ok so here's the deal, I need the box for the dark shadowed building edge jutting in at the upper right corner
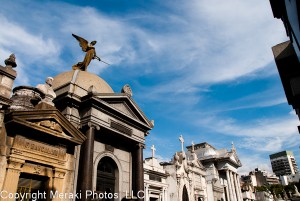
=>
[270,0,300,129]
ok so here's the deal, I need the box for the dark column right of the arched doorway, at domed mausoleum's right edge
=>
[132,143,144,201]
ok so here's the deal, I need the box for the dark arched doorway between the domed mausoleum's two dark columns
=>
[96,156,118,200]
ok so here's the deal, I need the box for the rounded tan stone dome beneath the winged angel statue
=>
[52,70,114,97]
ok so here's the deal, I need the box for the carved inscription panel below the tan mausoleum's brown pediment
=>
[13,135,66,160]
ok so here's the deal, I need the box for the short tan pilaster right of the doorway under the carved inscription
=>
[52,168,68,201]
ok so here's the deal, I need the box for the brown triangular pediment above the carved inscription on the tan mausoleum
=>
[5,109,86,144]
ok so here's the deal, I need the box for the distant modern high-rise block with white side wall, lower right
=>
[270,151,298,177]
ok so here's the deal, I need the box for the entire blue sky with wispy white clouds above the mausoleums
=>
[0,0,300,174]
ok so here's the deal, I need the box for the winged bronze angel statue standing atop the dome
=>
[72,34,108,71]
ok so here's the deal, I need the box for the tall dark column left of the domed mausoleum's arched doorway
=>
[77,123,100,201]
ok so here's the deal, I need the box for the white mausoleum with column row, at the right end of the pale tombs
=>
[187,142,243,201]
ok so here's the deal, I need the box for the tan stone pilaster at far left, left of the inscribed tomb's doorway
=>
[0,158,25,201]
